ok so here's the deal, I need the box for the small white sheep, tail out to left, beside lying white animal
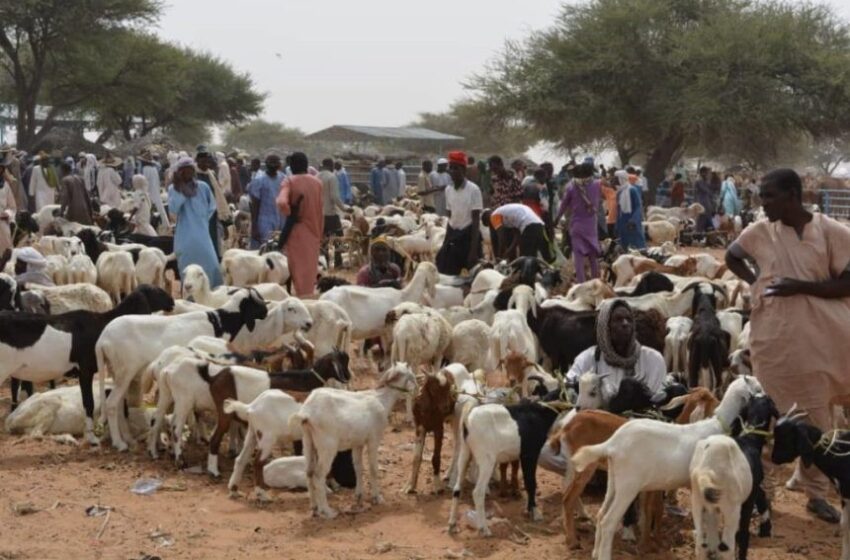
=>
[224,389,306,501]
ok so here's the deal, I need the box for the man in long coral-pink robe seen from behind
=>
[277,152,324,297]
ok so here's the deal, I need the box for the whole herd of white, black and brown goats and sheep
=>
[0,197,850,560]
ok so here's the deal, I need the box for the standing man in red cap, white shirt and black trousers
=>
[437,152,484,275]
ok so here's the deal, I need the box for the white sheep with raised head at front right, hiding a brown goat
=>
[573,377,764,560]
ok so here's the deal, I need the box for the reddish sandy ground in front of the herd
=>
[0,361,840,560]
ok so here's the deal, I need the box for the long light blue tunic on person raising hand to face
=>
[168,181,222,288]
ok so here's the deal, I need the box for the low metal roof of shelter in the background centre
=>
[306,124,464,151]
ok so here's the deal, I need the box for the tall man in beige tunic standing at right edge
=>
[726,169,850,523]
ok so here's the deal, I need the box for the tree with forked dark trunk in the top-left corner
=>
[0,0,160,148]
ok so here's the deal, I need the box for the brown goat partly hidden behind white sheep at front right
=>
[549,410,663,550]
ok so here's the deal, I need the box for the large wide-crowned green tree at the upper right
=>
[470,0,850,195]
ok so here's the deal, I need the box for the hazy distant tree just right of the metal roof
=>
[410,101,535,155]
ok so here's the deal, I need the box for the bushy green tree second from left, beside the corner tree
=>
[84,31,264,142]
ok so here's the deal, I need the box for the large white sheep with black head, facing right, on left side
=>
[95,289,268,451]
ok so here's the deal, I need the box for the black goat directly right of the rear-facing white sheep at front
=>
[735,395,779,560]
